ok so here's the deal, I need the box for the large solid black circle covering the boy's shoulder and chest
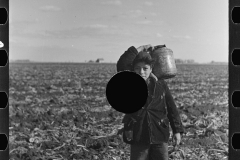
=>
[106,71,148,114]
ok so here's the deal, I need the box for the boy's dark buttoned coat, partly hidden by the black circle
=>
[122,77,184,144]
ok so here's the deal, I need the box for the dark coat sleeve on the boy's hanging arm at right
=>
[163,81,185,134]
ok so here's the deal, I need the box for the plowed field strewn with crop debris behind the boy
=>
[9,63,228,160]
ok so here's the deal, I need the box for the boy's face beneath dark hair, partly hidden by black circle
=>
[134,62,152,81]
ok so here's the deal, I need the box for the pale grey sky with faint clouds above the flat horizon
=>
[9,0,228,63]
